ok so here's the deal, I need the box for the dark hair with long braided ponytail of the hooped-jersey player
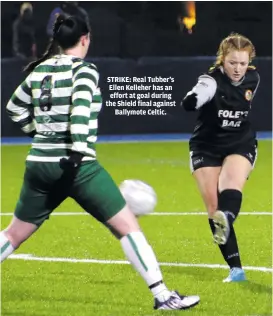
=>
[24,14,90,72]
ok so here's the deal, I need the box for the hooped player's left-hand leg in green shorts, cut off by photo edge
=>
[0,162,69,262]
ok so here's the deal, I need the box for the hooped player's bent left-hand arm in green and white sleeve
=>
[6,76,36,137]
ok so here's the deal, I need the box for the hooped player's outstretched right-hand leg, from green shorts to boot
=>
[71,162,200,310]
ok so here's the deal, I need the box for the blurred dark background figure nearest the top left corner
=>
[12,2,36,58]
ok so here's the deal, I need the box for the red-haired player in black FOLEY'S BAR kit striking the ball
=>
[182,33,260,282]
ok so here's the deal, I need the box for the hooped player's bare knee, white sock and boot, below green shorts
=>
[107,205,200,310]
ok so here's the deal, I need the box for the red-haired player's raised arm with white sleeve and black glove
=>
[182,75,217,111]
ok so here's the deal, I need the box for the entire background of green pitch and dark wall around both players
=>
[1,1,272,316]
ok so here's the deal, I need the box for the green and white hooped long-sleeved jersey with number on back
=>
[7,55,102,162]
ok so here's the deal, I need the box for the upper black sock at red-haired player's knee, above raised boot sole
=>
[218,189,242,225]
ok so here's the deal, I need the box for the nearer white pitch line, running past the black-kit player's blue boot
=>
[8,254,273,273]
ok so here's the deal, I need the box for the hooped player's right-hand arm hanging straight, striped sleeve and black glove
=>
[60,65,99,167]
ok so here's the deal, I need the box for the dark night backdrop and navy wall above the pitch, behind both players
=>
[1,1,272,136]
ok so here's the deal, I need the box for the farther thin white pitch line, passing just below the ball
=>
[0,212,273,216]
